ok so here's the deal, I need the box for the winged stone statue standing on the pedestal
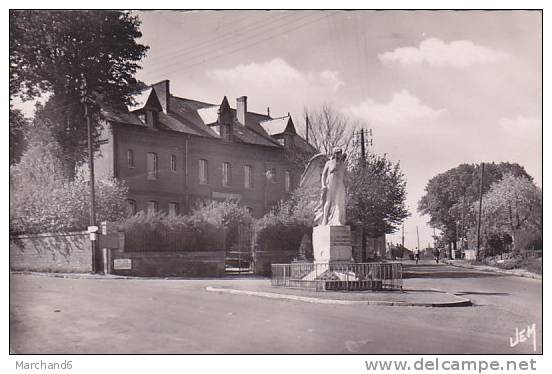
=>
[300,148,347,226]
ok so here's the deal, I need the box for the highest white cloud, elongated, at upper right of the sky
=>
[378,38,507,68]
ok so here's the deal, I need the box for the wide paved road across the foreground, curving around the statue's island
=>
[10,264,542,353]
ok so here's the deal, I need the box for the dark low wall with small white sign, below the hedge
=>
[107,249,226,277]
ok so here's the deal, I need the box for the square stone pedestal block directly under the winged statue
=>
[312,226,353,264]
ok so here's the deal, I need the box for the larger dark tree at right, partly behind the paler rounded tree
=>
[418,162,532,251]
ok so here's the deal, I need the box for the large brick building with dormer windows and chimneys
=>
[96,80,315,217]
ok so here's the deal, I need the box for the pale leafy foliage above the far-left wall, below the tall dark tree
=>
[10,127,128,233]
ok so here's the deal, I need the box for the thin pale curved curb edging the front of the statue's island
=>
[205,286,472,308]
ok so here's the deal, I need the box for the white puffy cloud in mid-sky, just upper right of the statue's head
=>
[346,90,446,125]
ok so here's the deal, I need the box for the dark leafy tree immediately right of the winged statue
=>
[347,154,409,238]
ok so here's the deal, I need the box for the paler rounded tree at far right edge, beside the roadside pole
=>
[482,174,542,250]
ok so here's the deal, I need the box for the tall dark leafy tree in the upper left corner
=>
[9,10,148,172]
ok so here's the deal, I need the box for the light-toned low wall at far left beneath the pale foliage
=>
[10,232,92,273]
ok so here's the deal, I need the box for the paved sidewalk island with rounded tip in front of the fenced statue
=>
[206,281,471,307]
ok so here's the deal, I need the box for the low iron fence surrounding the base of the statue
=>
[272,262,402,291]
